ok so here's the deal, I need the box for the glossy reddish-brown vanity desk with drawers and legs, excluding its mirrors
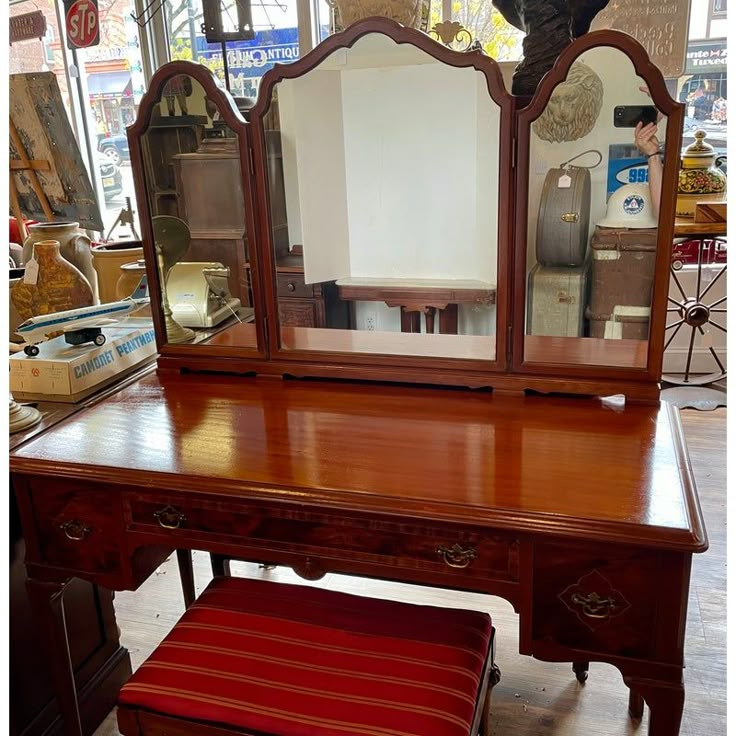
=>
[10,375,707,736]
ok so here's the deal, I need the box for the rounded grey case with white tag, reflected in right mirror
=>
[536,166,590,266]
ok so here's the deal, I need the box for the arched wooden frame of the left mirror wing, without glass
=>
[126,61,267,360]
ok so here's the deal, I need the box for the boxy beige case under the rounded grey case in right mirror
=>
[527,260,590,337]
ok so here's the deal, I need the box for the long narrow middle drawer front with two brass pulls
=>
[126,495,518,582]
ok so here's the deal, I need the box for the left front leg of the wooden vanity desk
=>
[26,578,82,736]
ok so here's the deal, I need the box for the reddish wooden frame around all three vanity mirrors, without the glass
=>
[137,28,684,401]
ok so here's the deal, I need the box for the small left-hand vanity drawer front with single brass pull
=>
[31,481,123,573]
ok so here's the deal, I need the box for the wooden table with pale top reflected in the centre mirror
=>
[337,278,496,335]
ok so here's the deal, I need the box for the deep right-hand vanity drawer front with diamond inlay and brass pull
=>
[532,544,663,657]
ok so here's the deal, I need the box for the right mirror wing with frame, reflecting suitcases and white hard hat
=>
[515,33,681,376]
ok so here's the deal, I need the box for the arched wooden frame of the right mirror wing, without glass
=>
[511,30,685,398]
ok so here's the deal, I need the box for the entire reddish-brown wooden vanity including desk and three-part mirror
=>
[11,18,707,736]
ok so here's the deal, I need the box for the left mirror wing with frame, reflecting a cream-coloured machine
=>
[129,62,259,351]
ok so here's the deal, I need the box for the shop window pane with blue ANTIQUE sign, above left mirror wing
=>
[165,0,299,97]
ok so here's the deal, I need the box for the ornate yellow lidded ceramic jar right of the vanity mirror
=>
[677,130,726,217]
